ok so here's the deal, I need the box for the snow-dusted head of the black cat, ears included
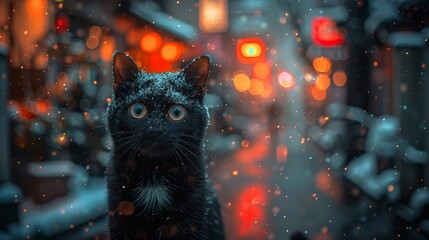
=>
[107,52,210,157]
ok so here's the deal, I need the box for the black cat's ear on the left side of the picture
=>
[113,52,140,91]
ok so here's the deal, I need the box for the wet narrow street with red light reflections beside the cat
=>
[209,20,347,240]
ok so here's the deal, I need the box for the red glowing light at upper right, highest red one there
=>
[311,16,345,47]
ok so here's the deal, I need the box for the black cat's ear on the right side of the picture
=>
[182,56,210,100]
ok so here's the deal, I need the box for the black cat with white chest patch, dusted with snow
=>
[107,52,224,239]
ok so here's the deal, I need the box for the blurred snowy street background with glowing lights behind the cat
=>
[0,0,429,240]
